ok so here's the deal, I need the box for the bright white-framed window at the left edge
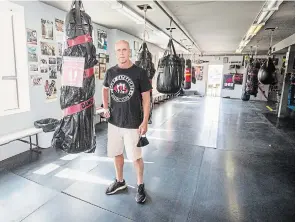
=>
[0,2,30,116]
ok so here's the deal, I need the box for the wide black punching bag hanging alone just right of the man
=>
[156,39,182,94]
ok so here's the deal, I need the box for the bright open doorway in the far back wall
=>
[207,65,223,97]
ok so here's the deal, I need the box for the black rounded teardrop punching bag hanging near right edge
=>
[258,57,275,85]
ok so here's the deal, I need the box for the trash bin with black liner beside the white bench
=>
[34,118,59,149]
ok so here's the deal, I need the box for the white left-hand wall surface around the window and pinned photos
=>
[0,1,163,161]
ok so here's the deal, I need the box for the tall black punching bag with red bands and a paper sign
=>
[52,1,97,153]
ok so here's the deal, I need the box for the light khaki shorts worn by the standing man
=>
[107,123,142,161]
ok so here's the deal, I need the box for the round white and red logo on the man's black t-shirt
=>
[110,75,135,102]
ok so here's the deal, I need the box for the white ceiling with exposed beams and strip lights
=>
[41,0,295,54]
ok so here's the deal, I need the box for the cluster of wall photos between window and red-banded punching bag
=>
[27,18,64,102]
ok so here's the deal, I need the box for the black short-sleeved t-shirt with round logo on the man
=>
[103,65,152,129]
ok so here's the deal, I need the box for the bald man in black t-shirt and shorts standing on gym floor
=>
[102,40,152,203]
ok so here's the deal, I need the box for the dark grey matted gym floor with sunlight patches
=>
[0,97,295,222]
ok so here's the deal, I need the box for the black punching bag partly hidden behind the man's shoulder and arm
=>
[135,42,156,124]
